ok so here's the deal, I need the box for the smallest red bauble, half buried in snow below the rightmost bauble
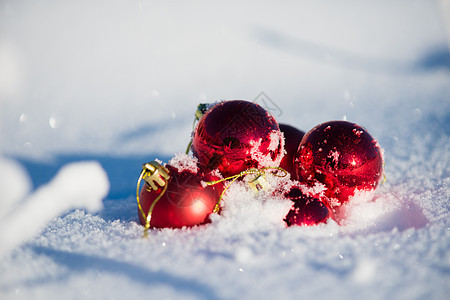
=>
[284,187,334,226]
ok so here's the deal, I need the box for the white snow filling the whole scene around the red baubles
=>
[0,0,450,299]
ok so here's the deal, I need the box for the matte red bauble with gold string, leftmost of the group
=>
[138,166,222,228]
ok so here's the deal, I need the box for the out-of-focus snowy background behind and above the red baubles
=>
[0,0,450,198]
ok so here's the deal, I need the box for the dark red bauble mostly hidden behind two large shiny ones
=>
[279,124,305,178]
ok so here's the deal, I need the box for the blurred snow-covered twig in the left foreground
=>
[0,161,109,257]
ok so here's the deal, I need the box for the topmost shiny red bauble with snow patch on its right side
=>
[192,100,284,177]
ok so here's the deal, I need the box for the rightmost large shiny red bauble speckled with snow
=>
[294,121,383,205]
